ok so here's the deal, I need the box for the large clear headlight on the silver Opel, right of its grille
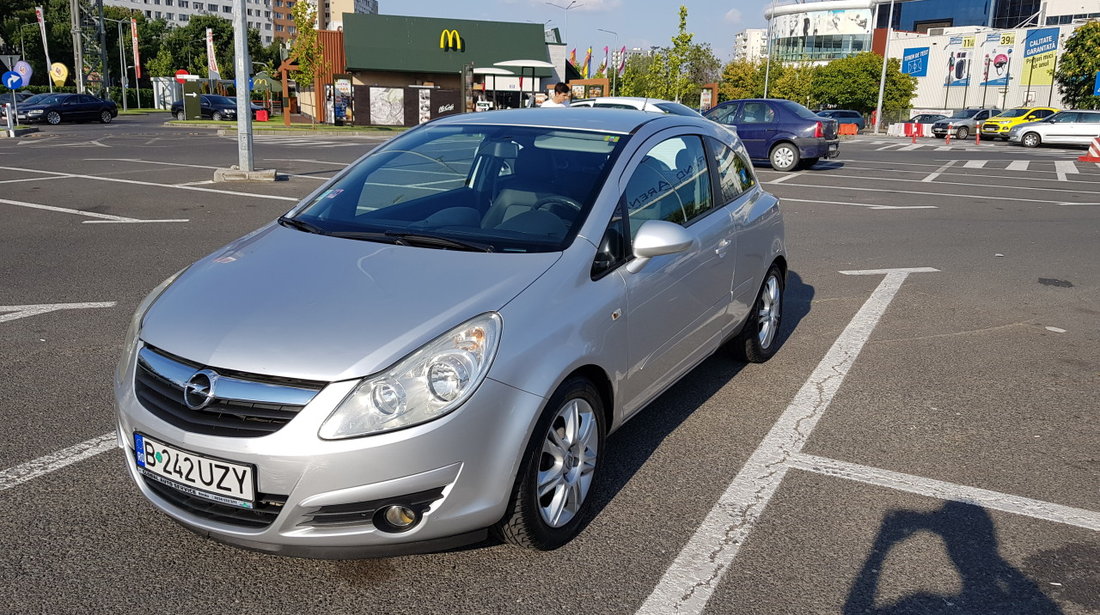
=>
[318,312,502,440]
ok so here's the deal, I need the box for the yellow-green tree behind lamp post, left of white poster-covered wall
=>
[811,52,916,117]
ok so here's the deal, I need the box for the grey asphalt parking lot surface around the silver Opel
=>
[0,116,1100,615]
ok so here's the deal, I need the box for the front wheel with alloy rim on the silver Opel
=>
[493,376,607,551]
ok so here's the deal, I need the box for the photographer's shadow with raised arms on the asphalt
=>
[843,502,1063,615]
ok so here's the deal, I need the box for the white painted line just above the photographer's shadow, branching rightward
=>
[787,453,1100,531]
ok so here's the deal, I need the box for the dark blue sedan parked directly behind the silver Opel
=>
[705,98,840,171]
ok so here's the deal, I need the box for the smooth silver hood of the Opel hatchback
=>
[141,224,561,382]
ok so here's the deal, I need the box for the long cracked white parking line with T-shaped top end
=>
[638,267,937,615]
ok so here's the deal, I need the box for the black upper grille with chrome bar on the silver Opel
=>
[134,347,320,438]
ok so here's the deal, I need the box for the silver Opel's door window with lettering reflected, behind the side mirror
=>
[623,136,713,239]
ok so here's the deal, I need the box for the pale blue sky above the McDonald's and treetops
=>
[378,0,767,64]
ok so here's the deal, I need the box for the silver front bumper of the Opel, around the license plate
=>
[116,341,545,559]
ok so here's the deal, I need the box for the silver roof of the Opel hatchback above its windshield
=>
[431,107,682,134]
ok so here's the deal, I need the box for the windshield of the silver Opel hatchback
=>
[283,125,627,252]
